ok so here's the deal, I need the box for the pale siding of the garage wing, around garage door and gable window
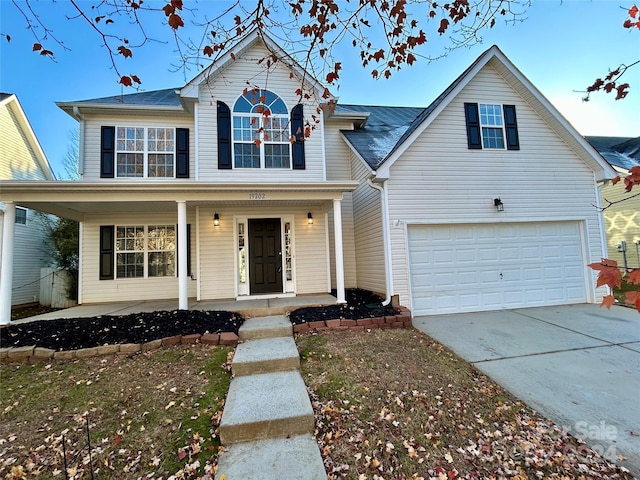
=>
[389,63,602,305]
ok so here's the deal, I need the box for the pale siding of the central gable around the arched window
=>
[198,45,324,182]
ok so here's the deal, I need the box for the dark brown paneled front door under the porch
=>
[248,218,282,295]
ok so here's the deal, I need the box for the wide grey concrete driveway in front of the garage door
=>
[413,304,640,477]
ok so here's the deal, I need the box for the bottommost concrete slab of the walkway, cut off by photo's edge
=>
[215,435,327,480]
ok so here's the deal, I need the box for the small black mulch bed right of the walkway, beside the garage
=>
[289,288,397,325]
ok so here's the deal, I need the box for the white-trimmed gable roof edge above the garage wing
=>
[342,45,615,180]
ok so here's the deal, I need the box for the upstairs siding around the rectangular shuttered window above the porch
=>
[82,115,196,182]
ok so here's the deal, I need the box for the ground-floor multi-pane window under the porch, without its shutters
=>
[115,225,176,278]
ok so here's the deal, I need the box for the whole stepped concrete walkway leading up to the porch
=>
[215,315,327,480]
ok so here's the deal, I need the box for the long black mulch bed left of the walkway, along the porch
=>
[0,310,244,351]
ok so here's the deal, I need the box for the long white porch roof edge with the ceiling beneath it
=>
[0,181,358,221]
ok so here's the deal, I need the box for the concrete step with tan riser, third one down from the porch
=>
[220,371,314,446]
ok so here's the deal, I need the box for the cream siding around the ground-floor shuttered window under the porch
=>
[80,214,196,303]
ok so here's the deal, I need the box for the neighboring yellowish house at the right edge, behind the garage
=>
[587,137,640,268]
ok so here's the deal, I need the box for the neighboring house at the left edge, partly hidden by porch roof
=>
[0,93,54,305]
